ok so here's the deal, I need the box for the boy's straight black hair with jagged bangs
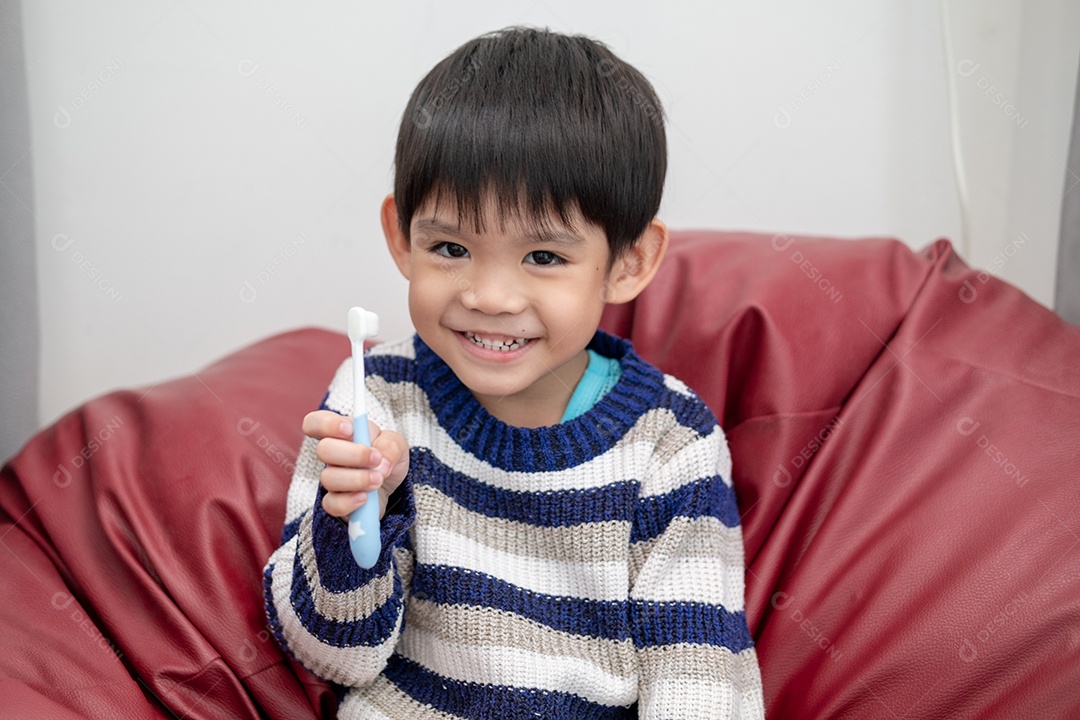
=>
[394,27,667,260]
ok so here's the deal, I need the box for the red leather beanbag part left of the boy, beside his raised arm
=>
[0,330,349,720]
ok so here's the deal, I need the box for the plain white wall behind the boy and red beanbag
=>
[16,0,1080,422]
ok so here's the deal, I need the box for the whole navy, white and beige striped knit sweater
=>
[264,331,764,720]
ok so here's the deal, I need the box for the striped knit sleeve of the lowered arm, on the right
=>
[631,395,765,720]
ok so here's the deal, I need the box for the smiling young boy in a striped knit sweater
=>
[265,28,764,720]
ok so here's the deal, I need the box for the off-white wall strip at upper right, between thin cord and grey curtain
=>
[947,0,1080,305]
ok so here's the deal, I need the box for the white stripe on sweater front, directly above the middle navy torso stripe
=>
[413,525,630,600]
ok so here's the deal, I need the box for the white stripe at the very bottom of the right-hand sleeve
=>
[638,677,765,720]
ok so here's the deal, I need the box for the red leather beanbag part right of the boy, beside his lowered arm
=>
[606,232,1080,719]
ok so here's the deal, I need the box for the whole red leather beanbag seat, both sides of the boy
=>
[0,231,1080,718]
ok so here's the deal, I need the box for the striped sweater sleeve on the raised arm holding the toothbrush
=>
[264,361,415,687]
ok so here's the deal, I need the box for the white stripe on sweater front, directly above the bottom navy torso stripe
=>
[397,628,637,705]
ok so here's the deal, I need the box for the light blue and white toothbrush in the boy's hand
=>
[349,308,382,570]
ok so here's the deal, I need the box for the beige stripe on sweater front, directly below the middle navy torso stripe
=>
[399,598,636,678]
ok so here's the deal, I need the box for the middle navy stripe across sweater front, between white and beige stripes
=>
[413,563,630,640]
